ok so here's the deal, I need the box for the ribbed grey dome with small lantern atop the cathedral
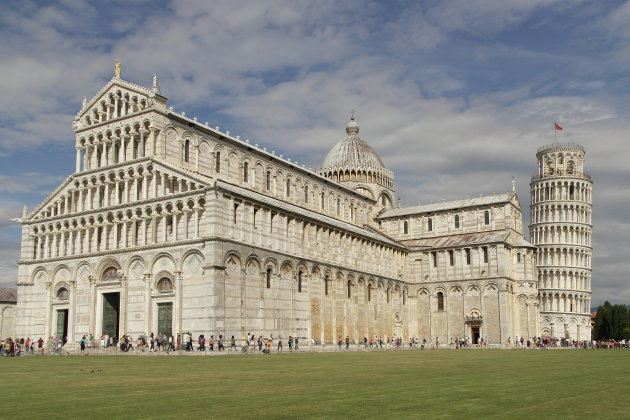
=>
[322,117,385,169]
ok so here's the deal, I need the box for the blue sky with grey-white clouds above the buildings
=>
[0,0,630,306]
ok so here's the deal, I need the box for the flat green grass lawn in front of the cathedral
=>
[0,350,630,419]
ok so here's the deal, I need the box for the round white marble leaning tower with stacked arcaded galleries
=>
[529,143,593,340]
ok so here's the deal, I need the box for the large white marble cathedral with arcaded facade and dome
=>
[16,64,556,345]
